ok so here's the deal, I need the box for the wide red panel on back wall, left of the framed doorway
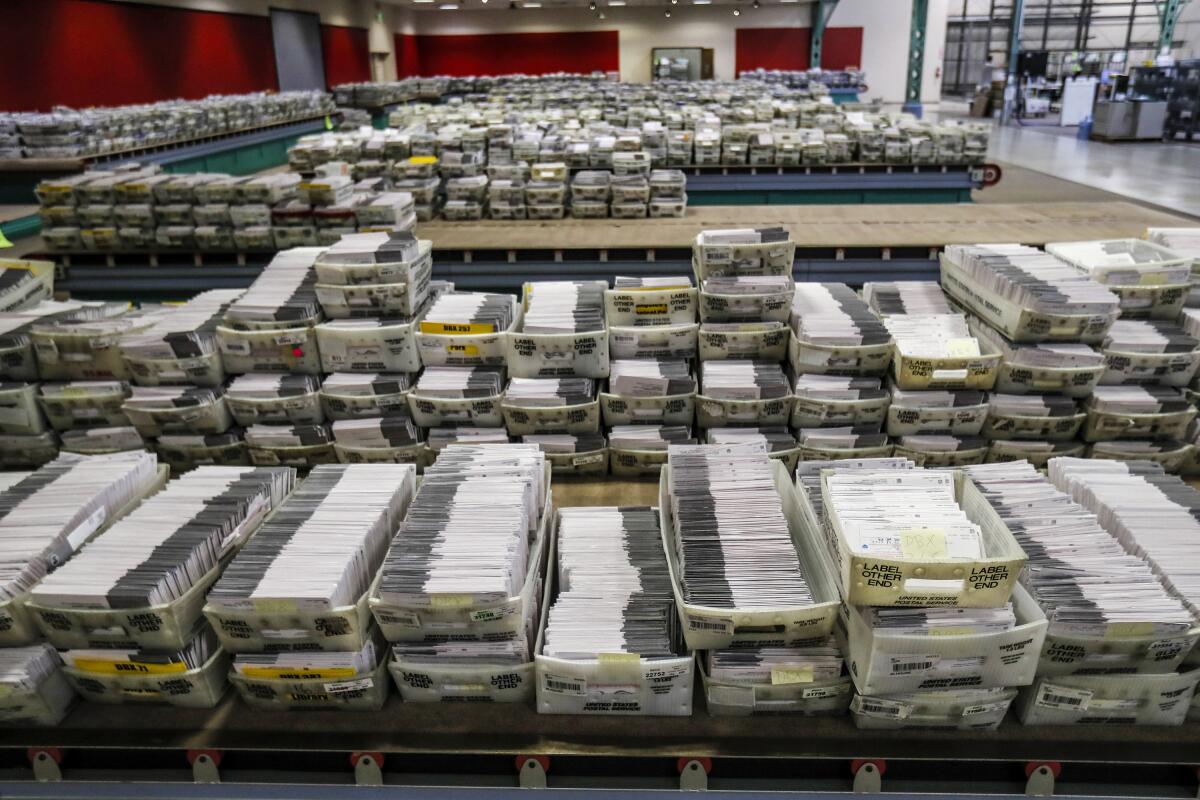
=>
[396,30,620,77]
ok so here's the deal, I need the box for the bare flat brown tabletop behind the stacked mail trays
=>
[418,203,1195,251]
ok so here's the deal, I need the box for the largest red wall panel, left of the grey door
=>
[0,0,278,110]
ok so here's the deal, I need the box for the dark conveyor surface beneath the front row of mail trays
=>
[7,687,1200,764]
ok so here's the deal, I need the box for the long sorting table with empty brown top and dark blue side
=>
[38,203,1192,299]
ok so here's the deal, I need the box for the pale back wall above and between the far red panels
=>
[397,0,926,103]
